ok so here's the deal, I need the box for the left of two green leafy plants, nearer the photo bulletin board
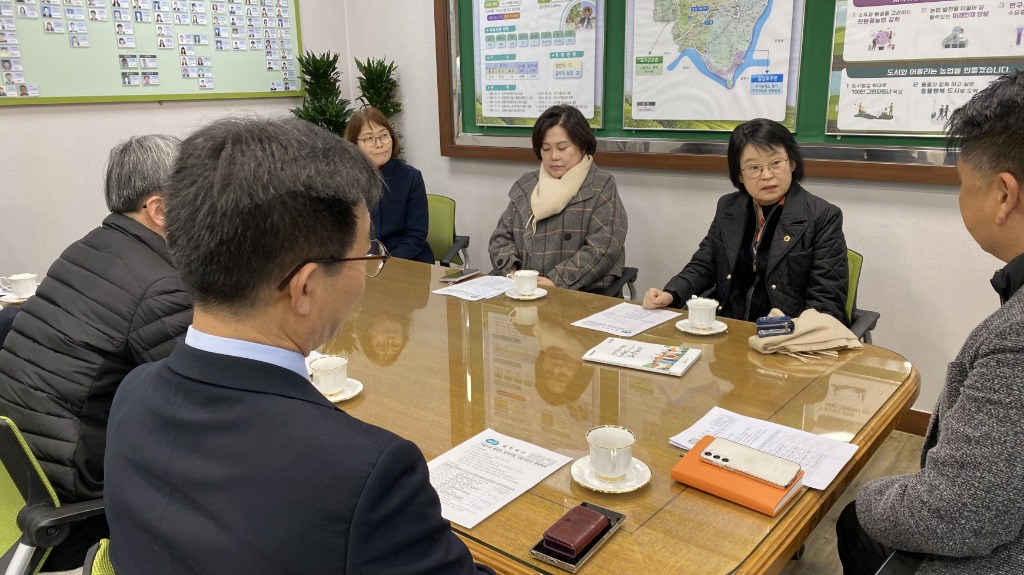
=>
[292,51,353,136]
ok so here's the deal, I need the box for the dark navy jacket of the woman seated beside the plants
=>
[380,159,434,264]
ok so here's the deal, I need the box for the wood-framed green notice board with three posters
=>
[435,0,1024,183]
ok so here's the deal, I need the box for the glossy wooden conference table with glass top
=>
[325,259,919,575]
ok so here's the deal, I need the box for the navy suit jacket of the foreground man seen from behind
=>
[104,344,494,575]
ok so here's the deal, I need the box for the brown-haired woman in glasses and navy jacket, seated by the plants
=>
[345,106,434,264]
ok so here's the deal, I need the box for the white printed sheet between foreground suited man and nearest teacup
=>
[428,429,572,529]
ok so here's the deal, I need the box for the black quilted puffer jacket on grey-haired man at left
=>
[0,214,193,501]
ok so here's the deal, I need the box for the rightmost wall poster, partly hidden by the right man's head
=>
[825,0,1024,136]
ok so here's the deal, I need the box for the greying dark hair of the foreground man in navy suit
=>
[165,118,381,316]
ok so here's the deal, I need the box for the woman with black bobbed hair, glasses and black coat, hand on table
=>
[643,118,848,321]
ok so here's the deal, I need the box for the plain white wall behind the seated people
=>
[0,0,1000,411]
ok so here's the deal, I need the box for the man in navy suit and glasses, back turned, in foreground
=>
[104,119,494,575]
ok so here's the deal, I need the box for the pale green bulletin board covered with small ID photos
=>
[0,0,302,105]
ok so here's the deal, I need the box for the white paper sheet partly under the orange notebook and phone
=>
[669,407,857,489]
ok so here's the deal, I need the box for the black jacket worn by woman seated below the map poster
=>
[665,183,849,322]
